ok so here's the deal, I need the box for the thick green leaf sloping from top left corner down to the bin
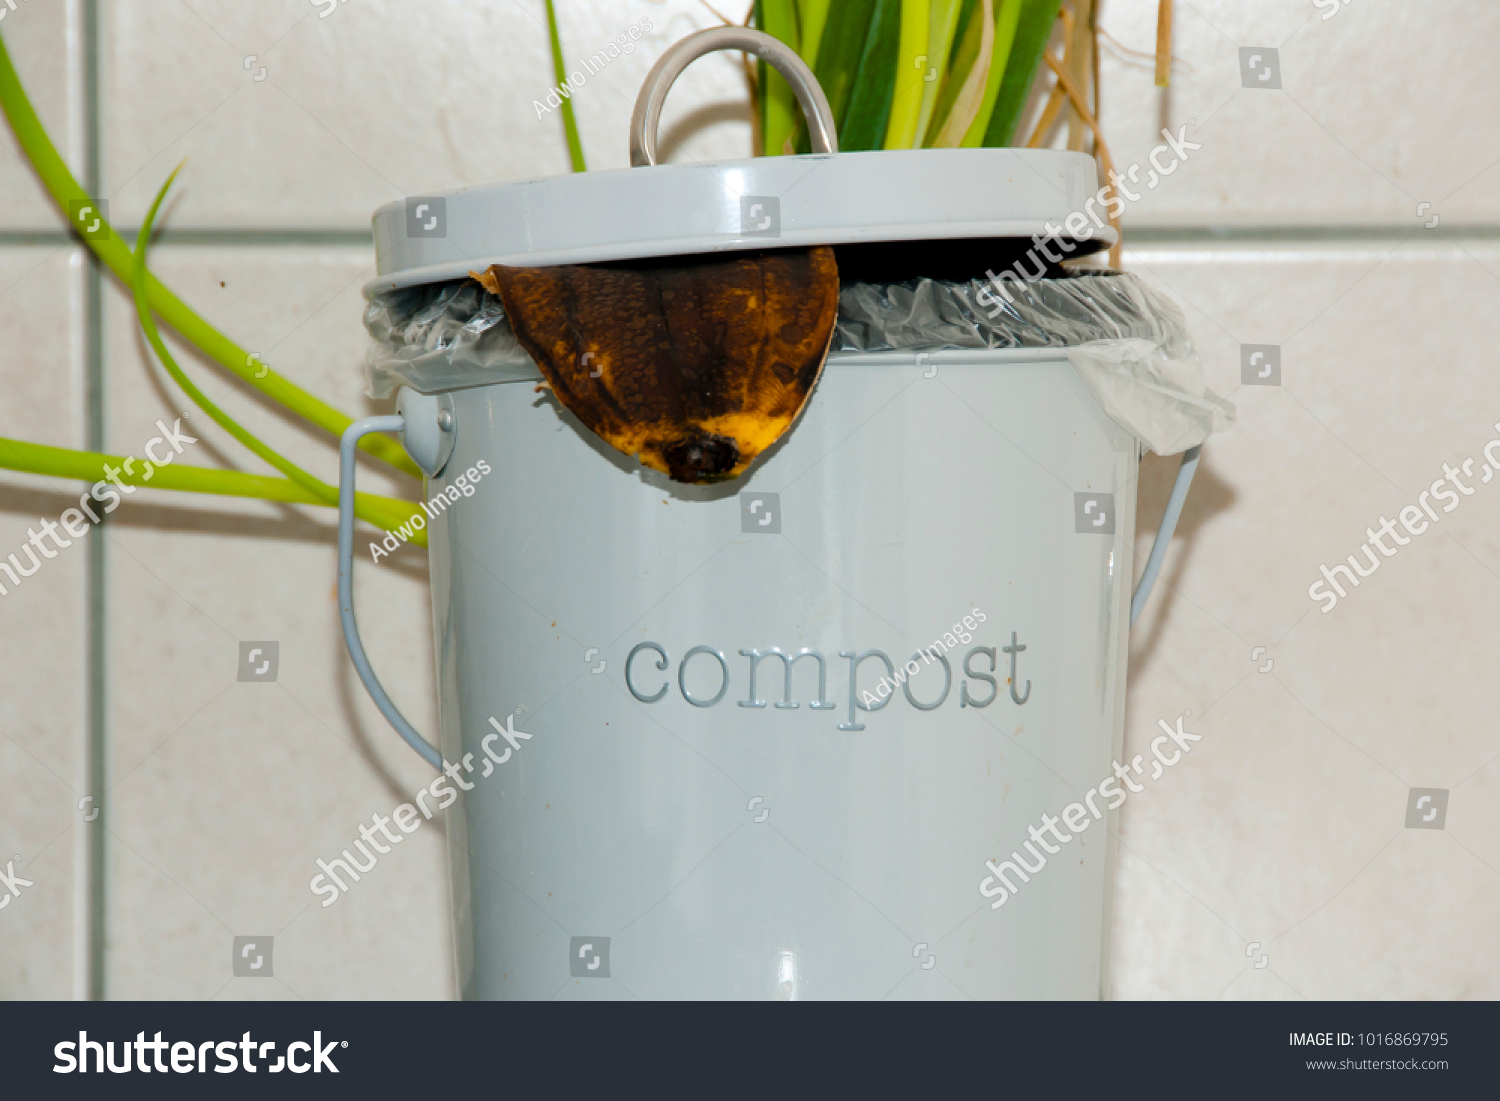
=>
[0,35,422,479]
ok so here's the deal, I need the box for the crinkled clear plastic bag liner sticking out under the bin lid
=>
[365,272,1235,455]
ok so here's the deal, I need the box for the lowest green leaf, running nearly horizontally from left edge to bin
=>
[0,437,428,546]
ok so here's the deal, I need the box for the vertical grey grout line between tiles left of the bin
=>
[84,0,110,1002]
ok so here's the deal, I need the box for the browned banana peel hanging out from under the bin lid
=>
[470,246,839,485]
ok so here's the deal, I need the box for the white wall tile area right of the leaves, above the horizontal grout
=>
[1101,0,1500,228]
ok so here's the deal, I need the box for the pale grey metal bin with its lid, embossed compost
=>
[331,30,1218,999]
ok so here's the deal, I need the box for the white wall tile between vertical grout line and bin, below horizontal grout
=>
[107,248,453,998]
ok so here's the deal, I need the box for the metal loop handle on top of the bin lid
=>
[630,27,839,168]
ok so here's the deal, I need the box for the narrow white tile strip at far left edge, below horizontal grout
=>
[0,246,87,998]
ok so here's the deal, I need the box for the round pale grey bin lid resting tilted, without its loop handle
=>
[365,149,1116,296]
